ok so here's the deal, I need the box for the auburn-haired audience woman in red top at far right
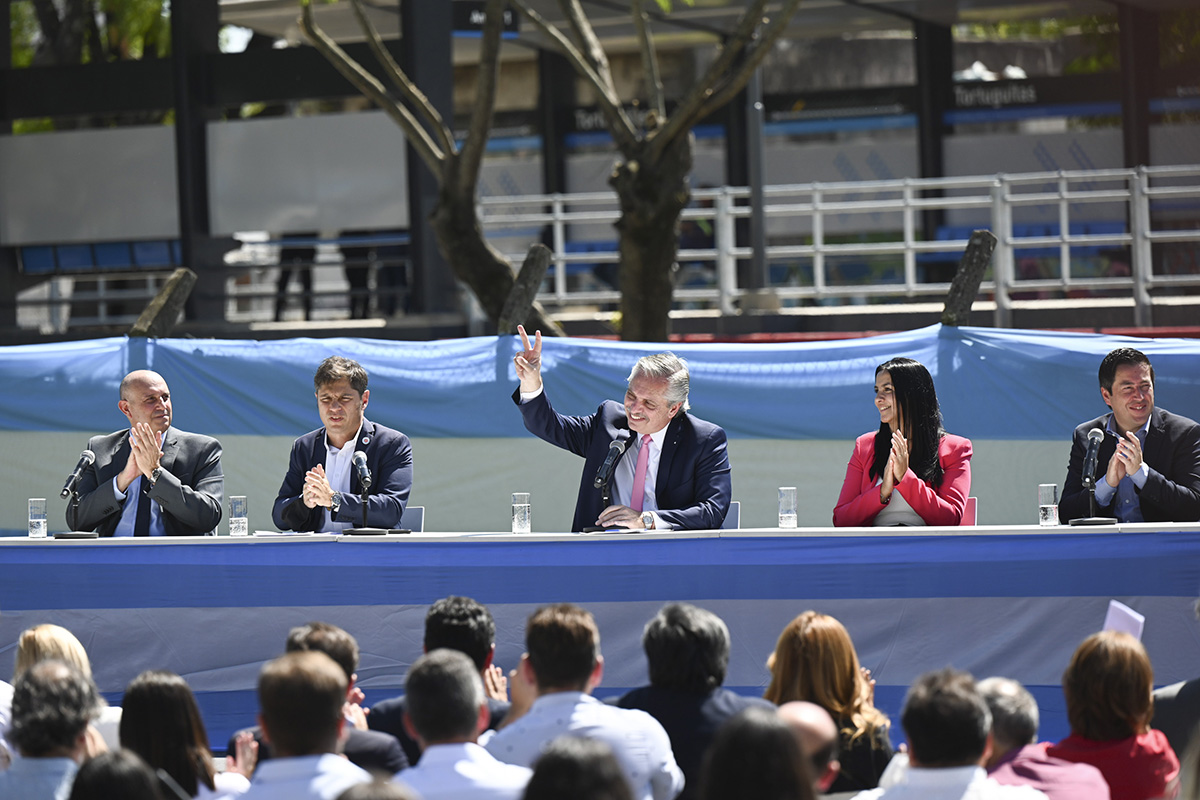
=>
[1046,631,1180,800]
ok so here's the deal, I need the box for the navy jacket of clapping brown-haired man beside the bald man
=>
[271,417,413,530]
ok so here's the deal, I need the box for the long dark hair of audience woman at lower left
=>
[120,669,216,798]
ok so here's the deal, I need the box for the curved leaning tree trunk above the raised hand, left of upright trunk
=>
[430,170,564,336]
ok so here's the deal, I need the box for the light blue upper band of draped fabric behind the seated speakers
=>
[0,325,1200,440]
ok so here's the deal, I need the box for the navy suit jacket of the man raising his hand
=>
[512,387,732,530]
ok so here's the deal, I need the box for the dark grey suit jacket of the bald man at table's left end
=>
[67,427,224,536]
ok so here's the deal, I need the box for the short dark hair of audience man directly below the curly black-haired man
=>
[404,649,485,744]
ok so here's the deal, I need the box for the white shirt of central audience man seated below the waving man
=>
[480,692,683,800]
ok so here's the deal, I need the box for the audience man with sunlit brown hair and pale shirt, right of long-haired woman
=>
[242,652,371,800]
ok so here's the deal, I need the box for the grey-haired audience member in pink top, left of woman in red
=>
[979,678,1109,800]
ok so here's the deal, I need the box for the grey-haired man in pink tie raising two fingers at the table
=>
[512,326,732,531]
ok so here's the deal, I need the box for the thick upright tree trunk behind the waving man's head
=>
[608,134,692,342]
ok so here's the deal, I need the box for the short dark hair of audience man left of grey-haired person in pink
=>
[900,667,991,768]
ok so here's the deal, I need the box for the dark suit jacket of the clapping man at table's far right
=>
[1058,408,1200,523]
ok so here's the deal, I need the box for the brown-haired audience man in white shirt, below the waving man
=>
[486,603,683,800]
